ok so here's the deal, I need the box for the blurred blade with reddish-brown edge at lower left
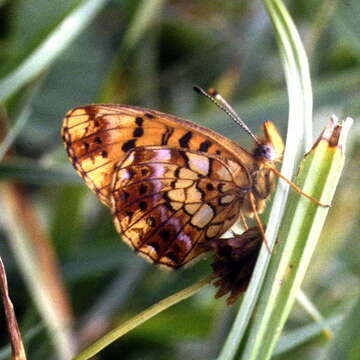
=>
[0,183,74,360]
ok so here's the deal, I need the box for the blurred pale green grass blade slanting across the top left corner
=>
[0,0,108,101]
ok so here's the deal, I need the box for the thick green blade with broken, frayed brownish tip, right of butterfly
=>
[241,119,352,360]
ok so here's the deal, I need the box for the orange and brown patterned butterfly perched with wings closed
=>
[62,90,326,268]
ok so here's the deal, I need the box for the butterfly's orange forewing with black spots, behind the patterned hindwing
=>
[62,105,253,206]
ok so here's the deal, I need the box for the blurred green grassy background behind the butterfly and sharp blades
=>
[0,0,360,360]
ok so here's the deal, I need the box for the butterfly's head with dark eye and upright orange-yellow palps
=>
[253,121,284,162]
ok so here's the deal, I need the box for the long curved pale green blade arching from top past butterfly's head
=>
[218,0,312,360]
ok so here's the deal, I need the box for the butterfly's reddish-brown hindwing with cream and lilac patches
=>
[110,146,250,268]
